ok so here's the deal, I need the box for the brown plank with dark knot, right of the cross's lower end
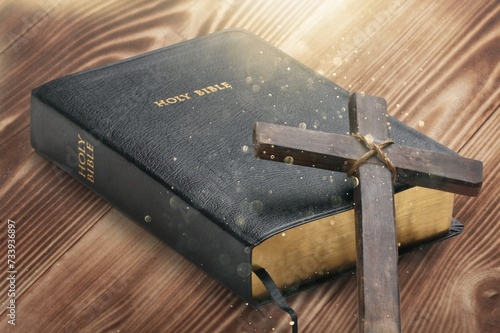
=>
[399,102,500,332]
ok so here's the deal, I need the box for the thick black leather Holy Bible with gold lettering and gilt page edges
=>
[31,30,463,305]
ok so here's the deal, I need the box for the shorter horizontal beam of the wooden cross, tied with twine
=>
[254,123,483,196]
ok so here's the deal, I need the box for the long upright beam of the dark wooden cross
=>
[349,93,401,332]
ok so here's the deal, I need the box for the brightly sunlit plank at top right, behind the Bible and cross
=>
[279,0,500,150]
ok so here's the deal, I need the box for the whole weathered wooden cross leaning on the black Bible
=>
[254,93,482,332]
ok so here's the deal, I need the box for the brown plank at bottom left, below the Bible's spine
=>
[0,209,239,332]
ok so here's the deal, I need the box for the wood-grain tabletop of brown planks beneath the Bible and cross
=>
[0,0,500,332]
